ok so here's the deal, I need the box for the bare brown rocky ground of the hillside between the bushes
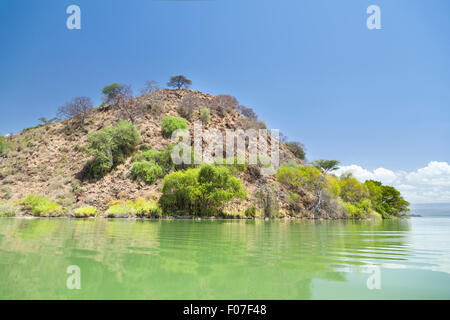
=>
[0,90,311,216]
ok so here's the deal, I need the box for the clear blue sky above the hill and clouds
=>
[0,0,450,178]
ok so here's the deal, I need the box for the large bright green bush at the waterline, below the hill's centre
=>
[160,164,245,215]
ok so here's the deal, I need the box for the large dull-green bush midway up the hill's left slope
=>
[85,121,140,179]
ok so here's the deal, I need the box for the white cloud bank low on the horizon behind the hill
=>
[335,161,450,203]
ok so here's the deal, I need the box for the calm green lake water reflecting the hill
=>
[0,218,450,299]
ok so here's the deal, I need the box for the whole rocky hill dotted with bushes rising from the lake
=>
[0,76,409,219]
